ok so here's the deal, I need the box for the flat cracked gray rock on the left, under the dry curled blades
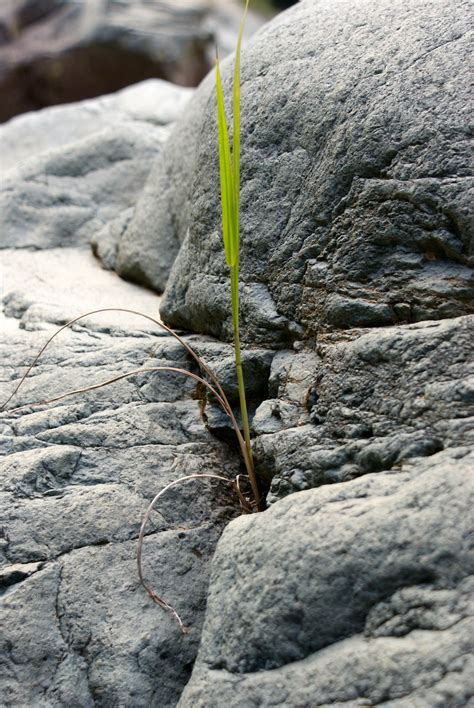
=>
[0,248,244,708]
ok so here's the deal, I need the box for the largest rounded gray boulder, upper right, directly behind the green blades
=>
[113,0,474,342]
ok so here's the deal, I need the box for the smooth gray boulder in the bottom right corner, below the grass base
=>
[179,448,474,708]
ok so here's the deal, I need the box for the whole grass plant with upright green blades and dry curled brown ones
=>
[0,0,262,632]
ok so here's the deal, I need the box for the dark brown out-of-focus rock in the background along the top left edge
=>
[0,0,294,122]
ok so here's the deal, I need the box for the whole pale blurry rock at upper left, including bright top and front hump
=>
[0,81,190,252]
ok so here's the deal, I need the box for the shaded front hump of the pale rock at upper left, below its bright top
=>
[0,128,160,248]
